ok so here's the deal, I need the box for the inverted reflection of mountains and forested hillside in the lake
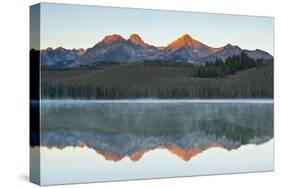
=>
[36,101,273,161]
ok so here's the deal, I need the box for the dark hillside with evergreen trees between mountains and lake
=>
[41,52,273,99]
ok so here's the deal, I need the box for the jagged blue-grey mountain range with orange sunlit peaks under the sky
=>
[41,34,273,67]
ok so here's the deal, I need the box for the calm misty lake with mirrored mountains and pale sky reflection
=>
[34,99,274,185]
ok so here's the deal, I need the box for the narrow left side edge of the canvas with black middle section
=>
[29,3,41,185]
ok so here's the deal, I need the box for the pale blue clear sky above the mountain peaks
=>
[38,3,274,54]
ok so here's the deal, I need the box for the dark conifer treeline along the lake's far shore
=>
[41,82,272,99]
